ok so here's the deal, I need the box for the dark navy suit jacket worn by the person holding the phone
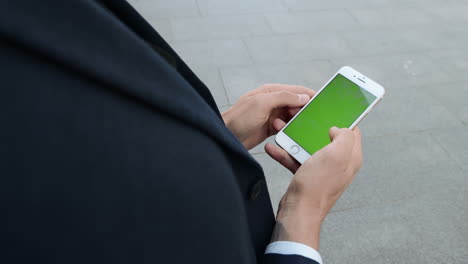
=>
[0,0,315,264]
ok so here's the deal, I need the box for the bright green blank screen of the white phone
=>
[284,74,376,154]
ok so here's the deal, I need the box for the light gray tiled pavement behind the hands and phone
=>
[131,0,468,264]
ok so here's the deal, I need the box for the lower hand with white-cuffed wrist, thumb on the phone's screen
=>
[265,127,362,249]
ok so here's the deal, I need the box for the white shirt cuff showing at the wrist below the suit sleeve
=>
[265,241,322,264]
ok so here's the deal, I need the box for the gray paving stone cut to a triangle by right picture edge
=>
[431,126,468,171]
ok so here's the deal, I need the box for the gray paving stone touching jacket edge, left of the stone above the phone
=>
[172,40,252,67]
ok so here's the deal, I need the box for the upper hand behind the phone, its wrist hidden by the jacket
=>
[222,84,315,149]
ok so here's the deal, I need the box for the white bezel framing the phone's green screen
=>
[275,66,385,164]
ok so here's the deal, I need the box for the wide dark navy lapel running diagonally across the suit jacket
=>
[0,0,259,167]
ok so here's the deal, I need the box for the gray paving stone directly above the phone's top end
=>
[245,33,354,63]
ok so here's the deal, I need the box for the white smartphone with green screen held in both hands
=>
[275,66,385,164]
